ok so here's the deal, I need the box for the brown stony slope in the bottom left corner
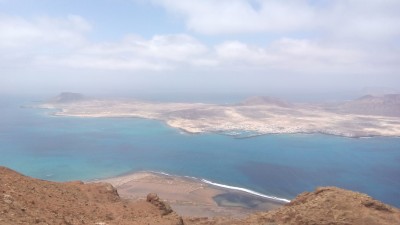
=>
[0,167,182,225]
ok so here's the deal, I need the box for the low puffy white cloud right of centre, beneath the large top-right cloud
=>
[216,38,365,73]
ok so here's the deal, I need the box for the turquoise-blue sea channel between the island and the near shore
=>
[0,100,400,207]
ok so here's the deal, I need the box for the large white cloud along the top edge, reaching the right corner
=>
[151,0,400,41]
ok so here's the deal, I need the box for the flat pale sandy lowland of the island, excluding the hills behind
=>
[37,100,400,139]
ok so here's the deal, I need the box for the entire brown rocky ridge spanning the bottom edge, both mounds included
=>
[0,167,400,225]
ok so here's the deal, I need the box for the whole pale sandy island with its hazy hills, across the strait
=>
[39,93,400,138]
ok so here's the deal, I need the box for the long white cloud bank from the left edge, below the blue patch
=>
[0,15,215,70]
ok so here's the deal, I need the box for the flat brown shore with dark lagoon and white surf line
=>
[88,171,289,217]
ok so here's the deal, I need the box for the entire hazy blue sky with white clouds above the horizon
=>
[0,0,400,100]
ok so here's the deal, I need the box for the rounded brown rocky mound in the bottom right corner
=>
[246,187,400,225]
